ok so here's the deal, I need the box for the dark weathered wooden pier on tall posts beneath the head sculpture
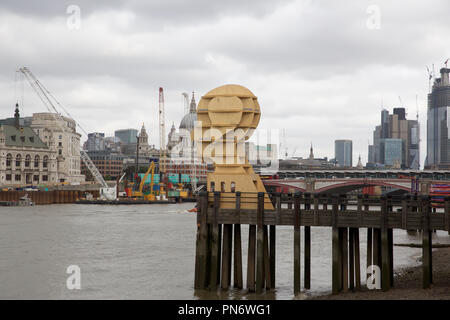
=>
[195,192,450,294]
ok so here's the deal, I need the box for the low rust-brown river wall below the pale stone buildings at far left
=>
[0,190,99,205]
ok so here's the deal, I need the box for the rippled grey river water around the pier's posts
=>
[0,203,449,299]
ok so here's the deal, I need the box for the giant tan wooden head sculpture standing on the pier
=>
[194,84,273,209]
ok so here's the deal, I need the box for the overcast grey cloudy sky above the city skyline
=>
[0,0,450,166]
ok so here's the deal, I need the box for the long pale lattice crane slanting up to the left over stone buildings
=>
[18,67,116,200]
